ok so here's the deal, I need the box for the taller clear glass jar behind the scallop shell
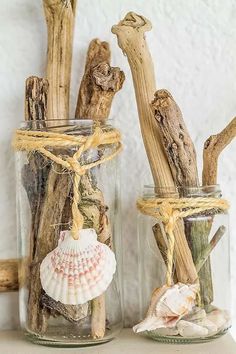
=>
[16,120,122,347]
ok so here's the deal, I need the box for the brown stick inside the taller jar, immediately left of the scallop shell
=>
[28,166,71,333]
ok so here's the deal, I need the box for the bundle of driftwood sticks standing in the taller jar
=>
[0,0,124,338]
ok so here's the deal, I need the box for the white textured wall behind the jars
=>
[0,0,236,328]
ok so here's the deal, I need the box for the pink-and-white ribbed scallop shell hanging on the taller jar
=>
[40,229,116,305]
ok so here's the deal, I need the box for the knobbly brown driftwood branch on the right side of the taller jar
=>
[75,39,124,338]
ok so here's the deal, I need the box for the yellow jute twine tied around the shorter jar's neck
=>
[137,197,229,286]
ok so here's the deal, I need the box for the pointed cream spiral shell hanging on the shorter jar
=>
[133,283,199,333]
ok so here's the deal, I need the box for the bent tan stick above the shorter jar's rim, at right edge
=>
[202,117,236,186]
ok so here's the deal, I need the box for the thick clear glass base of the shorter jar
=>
[145,328,228,344]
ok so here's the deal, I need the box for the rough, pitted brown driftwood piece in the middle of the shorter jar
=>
[151,90,213,306]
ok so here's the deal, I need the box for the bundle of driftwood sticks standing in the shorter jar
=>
[112,12,236,308]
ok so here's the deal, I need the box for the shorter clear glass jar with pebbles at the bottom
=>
[134,185,231,343]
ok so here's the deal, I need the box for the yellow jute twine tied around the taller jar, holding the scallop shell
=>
[13,127,122,239]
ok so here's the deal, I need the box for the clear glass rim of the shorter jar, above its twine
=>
[143,184,222,198]
